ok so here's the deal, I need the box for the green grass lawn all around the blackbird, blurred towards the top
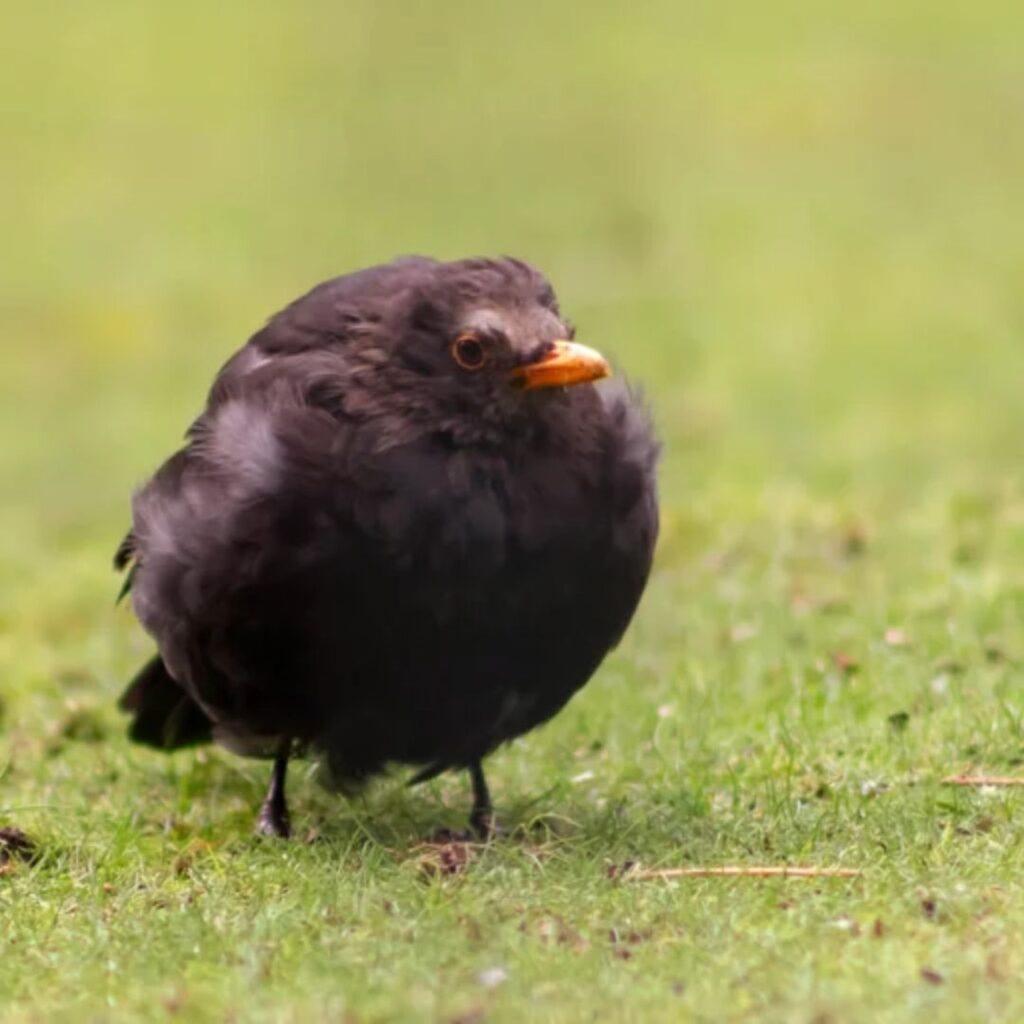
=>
[0,0,1024,1024]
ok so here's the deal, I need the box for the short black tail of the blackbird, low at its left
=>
[118,654,213,751]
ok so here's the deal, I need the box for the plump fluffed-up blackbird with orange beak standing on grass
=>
[115,251,657,837]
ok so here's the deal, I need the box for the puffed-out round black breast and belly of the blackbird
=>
[140,387,656,777]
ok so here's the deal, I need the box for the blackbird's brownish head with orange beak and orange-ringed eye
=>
[254,257,610,434]
